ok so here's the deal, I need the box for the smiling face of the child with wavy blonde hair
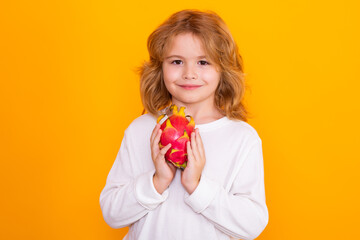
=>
[162,33,220,109]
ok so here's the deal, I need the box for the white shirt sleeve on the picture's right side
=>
[185,139,269,240]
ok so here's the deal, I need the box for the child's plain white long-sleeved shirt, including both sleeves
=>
[100,114,268,240]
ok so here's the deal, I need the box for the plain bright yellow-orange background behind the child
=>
[0,0,360,240]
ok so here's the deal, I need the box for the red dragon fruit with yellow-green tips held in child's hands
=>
[157,105,195,170]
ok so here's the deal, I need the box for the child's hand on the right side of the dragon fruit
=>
[181,128,206,194]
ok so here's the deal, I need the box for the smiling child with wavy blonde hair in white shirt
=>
[100,10,268,240]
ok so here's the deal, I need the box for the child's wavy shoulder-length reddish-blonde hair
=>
[139,10,248,121]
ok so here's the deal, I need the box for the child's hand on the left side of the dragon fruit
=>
[150,124,176,194]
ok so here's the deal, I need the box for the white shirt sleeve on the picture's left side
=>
[100,131,169,228]
